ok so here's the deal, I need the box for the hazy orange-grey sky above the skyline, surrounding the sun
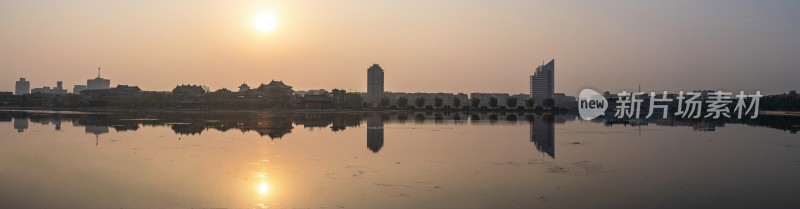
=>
[0,0,800,95]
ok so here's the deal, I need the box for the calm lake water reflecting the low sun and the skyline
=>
[0,111,800,209]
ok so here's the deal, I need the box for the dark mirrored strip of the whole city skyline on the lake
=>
[0,111,800,155]
